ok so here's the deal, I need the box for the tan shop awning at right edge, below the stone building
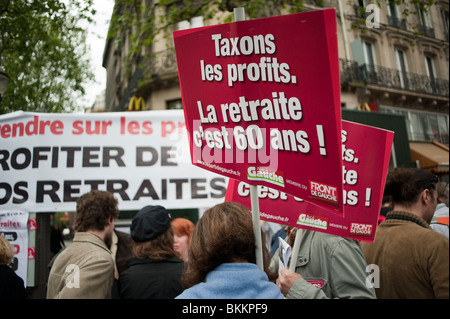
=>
[409,141,449,174]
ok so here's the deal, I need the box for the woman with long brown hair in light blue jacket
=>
[177,202,283,299]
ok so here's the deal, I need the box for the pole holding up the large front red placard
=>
[233,8,264,270]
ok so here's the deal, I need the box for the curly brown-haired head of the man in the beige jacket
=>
[75,190,119,232]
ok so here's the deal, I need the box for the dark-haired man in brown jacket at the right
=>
[361,168,449,299]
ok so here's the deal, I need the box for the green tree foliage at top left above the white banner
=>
[0,0,95,114]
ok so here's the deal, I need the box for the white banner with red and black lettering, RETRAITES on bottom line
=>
[0,110,227,212]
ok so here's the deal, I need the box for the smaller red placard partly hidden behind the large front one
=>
[225,121,394,242]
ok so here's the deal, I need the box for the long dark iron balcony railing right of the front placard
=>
[340,59,449,97]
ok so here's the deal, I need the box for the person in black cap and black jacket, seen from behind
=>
[119,205,184,299]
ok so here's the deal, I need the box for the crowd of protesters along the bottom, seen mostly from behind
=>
[0,168,449,299]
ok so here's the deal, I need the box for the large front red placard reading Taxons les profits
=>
[174,9,343,216]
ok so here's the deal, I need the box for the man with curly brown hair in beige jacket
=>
[47,190,119,299]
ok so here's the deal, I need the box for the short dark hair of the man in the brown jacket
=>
[384,167,438,206]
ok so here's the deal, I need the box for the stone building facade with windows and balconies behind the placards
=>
[103,0,449,145]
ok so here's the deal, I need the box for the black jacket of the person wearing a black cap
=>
[119,257,184,299]
